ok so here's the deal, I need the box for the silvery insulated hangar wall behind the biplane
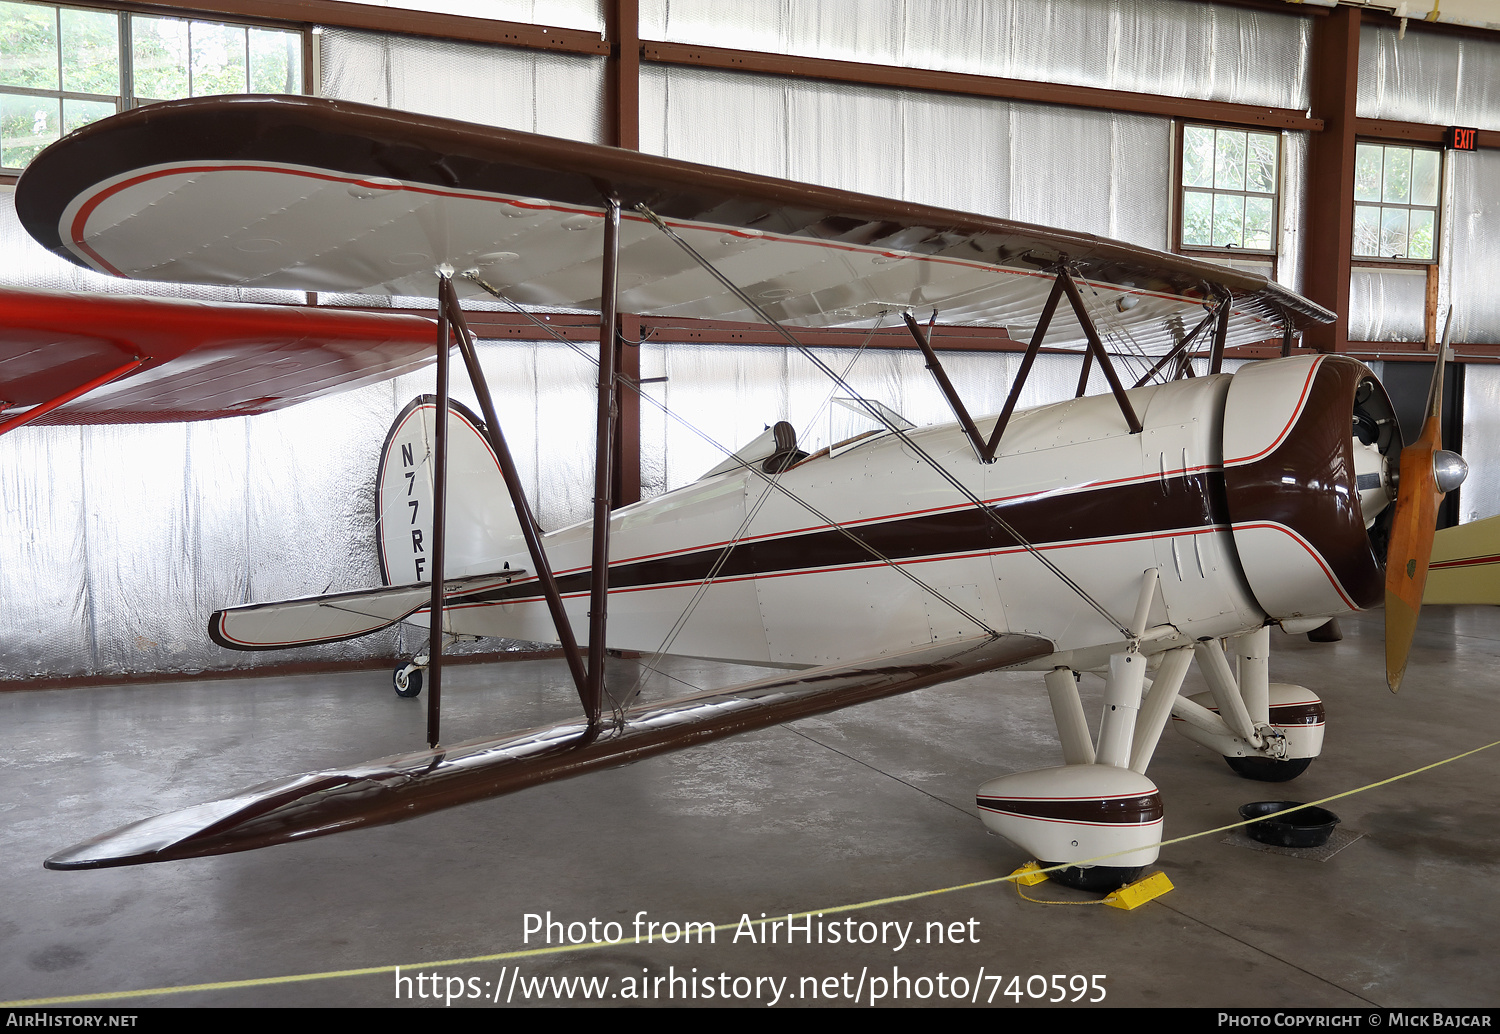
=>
[0,0,1500,678]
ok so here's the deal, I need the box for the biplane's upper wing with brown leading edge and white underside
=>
[17,98,1334,351]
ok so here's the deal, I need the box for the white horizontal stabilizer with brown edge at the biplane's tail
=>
[209,567,527,650]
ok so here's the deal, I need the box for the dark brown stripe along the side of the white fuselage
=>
[464,471,1229,606]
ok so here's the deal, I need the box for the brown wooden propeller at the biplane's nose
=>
[1386,309,1467,693]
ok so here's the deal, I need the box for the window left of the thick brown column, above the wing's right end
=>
[1179,126,1281,255]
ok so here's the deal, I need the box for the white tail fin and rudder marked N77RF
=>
[375,395,527,585]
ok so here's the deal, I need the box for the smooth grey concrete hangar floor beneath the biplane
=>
[0,608,1500,1007]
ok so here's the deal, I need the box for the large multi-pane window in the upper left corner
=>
[0,0,302,171]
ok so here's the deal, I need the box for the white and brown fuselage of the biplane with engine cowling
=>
[426,359,1383,668]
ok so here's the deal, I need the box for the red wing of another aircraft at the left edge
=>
[0,283,437,425]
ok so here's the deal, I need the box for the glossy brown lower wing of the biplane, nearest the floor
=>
[47,635,1053,869]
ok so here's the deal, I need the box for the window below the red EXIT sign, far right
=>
[1355,144,1443,263]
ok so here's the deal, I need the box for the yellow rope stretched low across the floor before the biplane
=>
[0,740,1500,1008]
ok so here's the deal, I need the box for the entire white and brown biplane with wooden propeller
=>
[8,98,1466,887]
